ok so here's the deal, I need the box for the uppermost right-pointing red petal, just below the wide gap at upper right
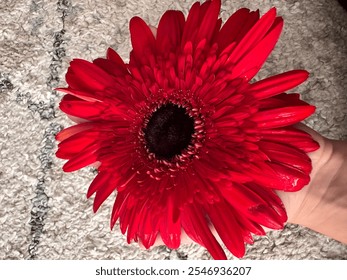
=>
[249,70,309,99]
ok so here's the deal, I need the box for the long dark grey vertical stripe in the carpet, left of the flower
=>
[28,0,71,259]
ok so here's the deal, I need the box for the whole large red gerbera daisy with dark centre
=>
[57,0,318,259]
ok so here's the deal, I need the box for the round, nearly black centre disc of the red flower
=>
[144,103,194,159]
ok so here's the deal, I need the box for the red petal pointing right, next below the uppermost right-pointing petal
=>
[252,105,315,129]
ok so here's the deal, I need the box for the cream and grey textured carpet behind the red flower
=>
[0,0,347,259]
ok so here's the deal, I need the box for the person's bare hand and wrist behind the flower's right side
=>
[278,125,347,244]
